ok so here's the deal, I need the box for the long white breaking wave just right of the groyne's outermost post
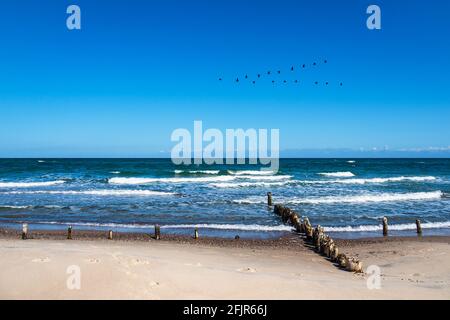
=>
[286,191,443,204]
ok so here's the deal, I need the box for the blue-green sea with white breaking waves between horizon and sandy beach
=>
[0,159,450,238]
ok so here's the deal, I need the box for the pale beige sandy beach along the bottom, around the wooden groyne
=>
[0,230,450,299]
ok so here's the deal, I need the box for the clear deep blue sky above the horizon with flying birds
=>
[0,0,450,157]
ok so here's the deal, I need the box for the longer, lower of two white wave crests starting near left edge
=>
[4,189,175,196]
